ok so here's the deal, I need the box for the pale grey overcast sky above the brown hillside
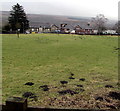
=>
[0,0,120,19]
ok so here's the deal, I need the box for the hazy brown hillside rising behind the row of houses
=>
[0,11,116,28]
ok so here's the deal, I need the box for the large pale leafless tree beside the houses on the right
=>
[92,14,108,34]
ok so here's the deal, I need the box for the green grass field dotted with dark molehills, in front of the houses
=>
[2,34,118,107]
